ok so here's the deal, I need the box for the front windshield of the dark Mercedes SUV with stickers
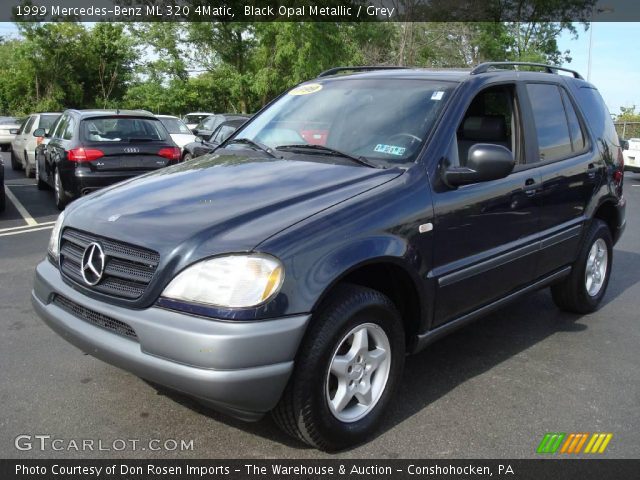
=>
[235,78,455,166]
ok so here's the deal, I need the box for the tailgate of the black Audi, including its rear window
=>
[79,117,179,172]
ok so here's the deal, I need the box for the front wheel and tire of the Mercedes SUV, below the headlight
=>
[272,285,405,451]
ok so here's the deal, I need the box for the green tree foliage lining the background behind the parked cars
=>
[0,19,592,114]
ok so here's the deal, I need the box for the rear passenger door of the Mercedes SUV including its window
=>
[526,83,605,276]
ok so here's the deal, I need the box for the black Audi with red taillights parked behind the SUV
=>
[33,110,181,210]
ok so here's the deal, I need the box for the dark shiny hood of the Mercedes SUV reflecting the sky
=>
[65,154,403,263]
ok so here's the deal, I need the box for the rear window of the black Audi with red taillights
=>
[80,117,167,142]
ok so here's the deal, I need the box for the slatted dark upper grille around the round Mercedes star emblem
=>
[60,228,160,300]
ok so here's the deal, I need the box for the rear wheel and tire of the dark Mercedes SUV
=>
[551,218,613,314]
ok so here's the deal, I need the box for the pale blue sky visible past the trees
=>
[0,20,640,114]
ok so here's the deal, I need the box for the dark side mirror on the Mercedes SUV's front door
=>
[442,143,516,187]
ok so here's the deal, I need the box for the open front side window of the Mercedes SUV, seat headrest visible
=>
[454,85,522,166]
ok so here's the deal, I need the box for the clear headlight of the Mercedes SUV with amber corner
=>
[162,254,284,307]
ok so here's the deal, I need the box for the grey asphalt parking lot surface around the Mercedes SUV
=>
[0,153,640,458]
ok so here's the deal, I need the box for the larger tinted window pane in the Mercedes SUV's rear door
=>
[527,83,572,162]
